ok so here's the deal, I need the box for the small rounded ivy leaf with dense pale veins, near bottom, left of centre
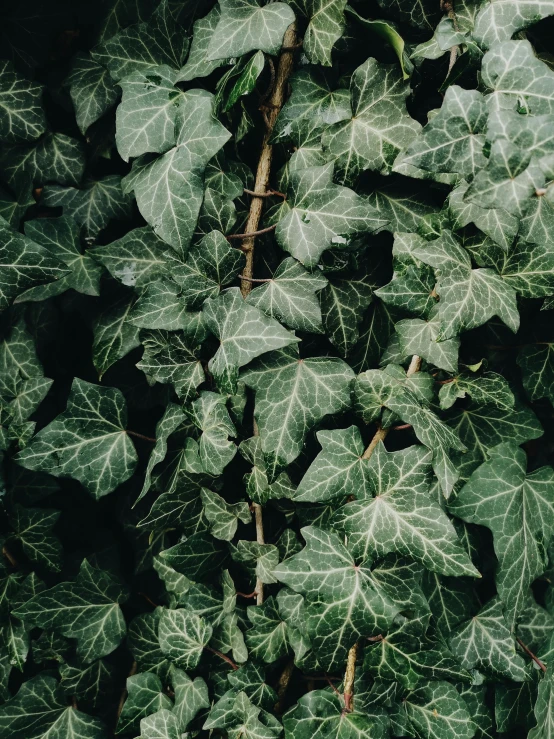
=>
[159,609,212,670]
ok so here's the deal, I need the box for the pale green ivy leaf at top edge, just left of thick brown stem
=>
[208,0,294,60]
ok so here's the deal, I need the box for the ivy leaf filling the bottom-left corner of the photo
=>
[0,675,105,739]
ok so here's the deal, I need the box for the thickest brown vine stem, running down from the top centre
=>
[241,23,296,297]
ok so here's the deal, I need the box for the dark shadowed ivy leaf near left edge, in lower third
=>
[10,505,63,572]
